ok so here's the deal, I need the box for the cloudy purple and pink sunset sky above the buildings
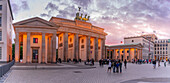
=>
[11,0,170,45]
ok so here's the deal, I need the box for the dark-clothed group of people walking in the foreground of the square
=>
[107,59,127,73]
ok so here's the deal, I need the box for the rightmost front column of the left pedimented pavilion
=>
[52,33,56,63]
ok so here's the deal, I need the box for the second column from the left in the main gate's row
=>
[74,33,79,60]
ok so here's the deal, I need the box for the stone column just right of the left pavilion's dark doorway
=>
[41,33,45,63]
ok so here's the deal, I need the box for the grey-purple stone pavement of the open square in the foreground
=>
[5,63,170,83]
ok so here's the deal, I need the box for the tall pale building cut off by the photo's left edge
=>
[0,0,13,62]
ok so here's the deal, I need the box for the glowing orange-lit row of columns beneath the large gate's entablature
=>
[58,32,105,61]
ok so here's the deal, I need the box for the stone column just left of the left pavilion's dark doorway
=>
[26,32,31,63]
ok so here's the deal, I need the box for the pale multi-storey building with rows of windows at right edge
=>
[154,39,170,60]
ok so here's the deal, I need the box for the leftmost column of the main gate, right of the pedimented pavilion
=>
[63,33,68,61]
